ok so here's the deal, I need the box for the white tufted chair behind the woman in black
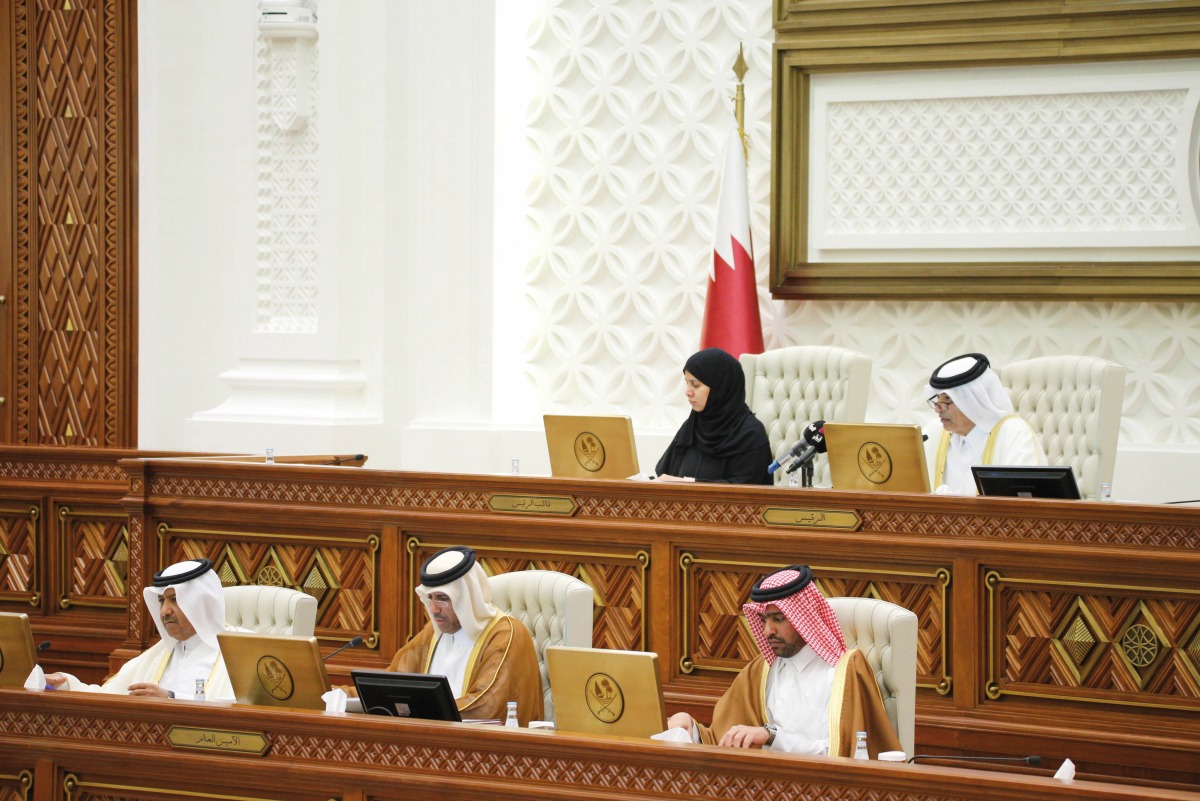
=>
[742,345,871,486]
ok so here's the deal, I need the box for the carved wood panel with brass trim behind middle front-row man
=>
[402,536,650,651]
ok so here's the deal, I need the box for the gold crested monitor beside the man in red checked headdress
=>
[546,645,667,737]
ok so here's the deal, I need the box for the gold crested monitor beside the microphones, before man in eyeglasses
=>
[824,422,929,493]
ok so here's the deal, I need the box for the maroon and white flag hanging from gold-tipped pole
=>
[700,130,762,356]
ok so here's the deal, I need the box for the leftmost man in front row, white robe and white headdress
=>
[46,559,234,701]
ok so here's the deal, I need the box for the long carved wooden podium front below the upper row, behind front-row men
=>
[0,448,1200,787]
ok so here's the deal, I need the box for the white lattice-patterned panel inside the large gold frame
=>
[814,88,1198,244]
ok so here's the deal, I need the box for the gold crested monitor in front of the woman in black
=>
[542,415,638,478]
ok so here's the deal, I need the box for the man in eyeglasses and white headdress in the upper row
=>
[925,354,1045,495]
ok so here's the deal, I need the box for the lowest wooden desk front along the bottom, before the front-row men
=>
[0,689,1200,801]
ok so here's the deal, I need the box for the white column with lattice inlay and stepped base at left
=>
[186,0,384,453]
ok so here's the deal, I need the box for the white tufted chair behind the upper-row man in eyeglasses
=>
[997,356,1128,499]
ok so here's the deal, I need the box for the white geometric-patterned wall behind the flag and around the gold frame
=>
[512,0,1200,450]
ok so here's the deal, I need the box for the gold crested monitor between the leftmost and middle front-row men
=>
[217,632,329,710]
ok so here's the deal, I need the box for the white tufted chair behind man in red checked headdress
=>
[829,598,917,757]
